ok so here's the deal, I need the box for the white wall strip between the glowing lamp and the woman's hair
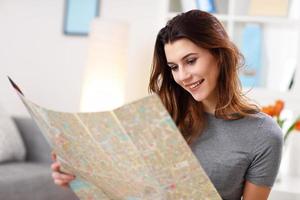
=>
[101,0,169,102]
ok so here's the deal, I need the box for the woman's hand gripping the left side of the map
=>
[51,153,75,187]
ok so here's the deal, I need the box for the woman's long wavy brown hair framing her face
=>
[149,10,259,144]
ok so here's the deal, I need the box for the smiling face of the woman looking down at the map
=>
[164,39,219,104]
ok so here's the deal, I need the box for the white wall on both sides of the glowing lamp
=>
[0,0,168,115]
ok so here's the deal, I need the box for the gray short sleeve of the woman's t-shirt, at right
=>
[245,116,283,187]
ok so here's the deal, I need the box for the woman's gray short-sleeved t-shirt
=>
[192,113,283,200]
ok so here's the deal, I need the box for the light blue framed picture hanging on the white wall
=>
[63,0,100,36]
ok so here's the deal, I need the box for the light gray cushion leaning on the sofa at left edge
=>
[0,108,26,163]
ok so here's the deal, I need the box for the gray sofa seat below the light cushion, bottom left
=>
[0,162,78,200]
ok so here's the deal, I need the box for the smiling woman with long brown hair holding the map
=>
[52,10,282,200]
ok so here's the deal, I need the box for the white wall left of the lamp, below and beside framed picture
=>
[0,0,88,115]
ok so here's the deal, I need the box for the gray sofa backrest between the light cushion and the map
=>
[13,117,51,163]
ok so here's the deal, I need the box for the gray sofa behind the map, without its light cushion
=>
[0,118,78,200]
